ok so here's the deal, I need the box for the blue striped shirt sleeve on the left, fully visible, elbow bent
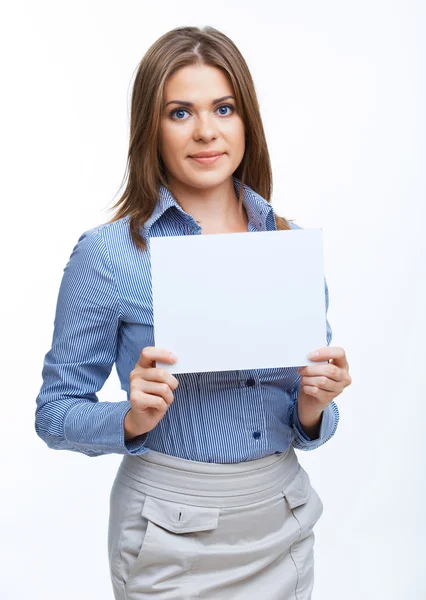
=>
[35,229,148,456]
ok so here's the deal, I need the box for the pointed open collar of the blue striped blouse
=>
[144,176,272,232]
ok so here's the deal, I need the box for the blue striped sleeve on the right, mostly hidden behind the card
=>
[289,278,339,450]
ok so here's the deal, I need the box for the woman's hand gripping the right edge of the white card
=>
[297,346,352,417]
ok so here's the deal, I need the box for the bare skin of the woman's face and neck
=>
[159,65,248,233]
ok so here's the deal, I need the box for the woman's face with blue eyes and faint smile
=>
[160,65,245,188]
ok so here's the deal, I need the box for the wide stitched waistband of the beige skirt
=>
[117,445,300,507]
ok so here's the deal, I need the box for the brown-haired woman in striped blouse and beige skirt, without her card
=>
[35,27,351,600]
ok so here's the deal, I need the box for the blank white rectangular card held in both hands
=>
[150,229,327,373]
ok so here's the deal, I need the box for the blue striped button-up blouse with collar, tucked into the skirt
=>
[35,177,339,463]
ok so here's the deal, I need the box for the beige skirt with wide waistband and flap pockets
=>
[108,446,323,600]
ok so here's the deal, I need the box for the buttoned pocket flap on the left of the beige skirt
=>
[142,496,219,533]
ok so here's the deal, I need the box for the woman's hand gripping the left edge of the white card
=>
[124,346,179,440]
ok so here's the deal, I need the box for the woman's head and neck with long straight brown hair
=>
[104,27,291,249]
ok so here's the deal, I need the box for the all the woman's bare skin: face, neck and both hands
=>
[124,66,352,440]
